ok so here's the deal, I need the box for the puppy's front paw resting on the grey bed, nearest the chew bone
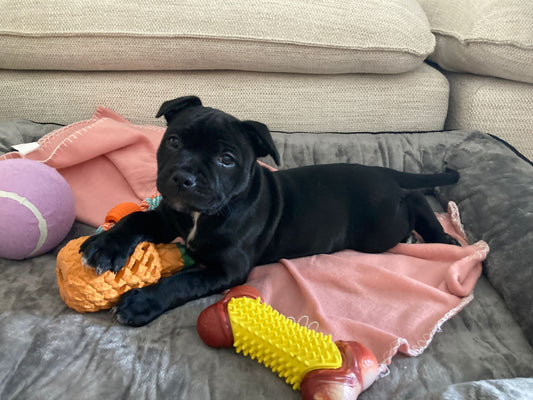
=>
[114,289,165,326]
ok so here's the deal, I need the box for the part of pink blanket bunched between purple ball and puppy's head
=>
[0,107,165,226]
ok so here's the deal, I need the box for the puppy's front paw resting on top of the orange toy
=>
[80,231,136,275]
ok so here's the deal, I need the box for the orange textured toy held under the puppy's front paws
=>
[56,198,194,313]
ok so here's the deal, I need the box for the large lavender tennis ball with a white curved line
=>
[0,159,75,260]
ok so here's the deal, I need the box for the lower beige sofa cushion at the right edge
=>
[446,73,533,160]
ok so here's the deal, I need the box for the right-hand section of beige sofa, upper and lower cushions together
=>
[419,0,533,159]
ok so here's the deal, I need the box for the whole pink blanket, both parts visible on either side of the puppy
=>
[0,107,488,368]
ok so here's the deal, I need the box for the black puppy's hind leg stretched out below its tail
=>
[405,192,459,245]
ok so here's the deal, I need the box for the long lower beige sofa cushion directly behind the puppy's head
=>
[0,64,448,132]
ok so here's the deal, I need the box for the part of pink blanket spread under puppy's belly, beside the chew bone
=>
[247,202,489,371]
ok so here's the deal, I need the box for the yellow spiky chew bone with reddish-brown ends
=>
[197,286,378,400]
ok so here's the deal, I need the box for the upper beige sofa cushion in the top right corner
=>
[419,0,533,83]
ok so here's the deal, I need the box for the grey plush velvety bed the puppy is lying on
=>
[0,121,533,400]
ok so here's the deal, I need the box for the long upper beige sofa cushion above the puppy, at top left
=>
[0,0,435,73]
